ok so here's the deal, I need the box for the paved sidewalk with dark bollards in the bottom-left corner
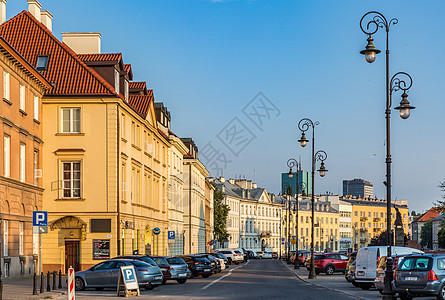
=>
[3,276,67,300]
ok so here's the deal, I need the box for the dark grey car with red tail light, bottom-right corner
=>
[392,253,445,300]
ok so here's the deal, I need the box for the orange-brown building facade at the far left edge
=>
[0,37,51,278]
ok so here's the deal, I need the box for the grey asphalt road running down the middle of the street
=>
[56,260,356,300]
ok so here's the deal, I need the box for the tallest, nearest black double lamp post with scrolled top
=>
[360,11,415,299]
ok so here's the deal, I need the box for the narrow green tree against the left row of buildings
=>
[212,182,230,243]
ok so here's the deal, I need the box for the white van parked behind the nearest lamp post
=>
[355,246,423,290]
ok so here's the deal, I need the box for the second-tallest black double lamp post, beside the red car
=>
[298,118,328,279]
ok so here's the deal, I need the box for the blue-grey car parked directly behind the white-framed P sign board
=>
[75,258,164,291]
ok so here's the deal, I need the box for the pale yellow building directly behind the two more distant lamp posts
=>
[281,198,340,253]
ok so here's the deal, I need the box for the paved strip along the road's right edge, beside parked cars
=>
[282,261,381,300]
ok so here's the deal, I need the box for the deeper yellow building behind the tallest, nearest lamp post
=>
[340,197,408,250]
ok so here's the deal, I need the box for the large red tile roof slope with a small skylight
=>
[0,11,117,96]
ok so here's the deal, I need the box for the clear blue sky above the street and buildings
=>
[7,0,445,211]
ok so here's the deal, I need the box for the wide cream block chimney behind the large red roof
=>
[62,32,102,54]
